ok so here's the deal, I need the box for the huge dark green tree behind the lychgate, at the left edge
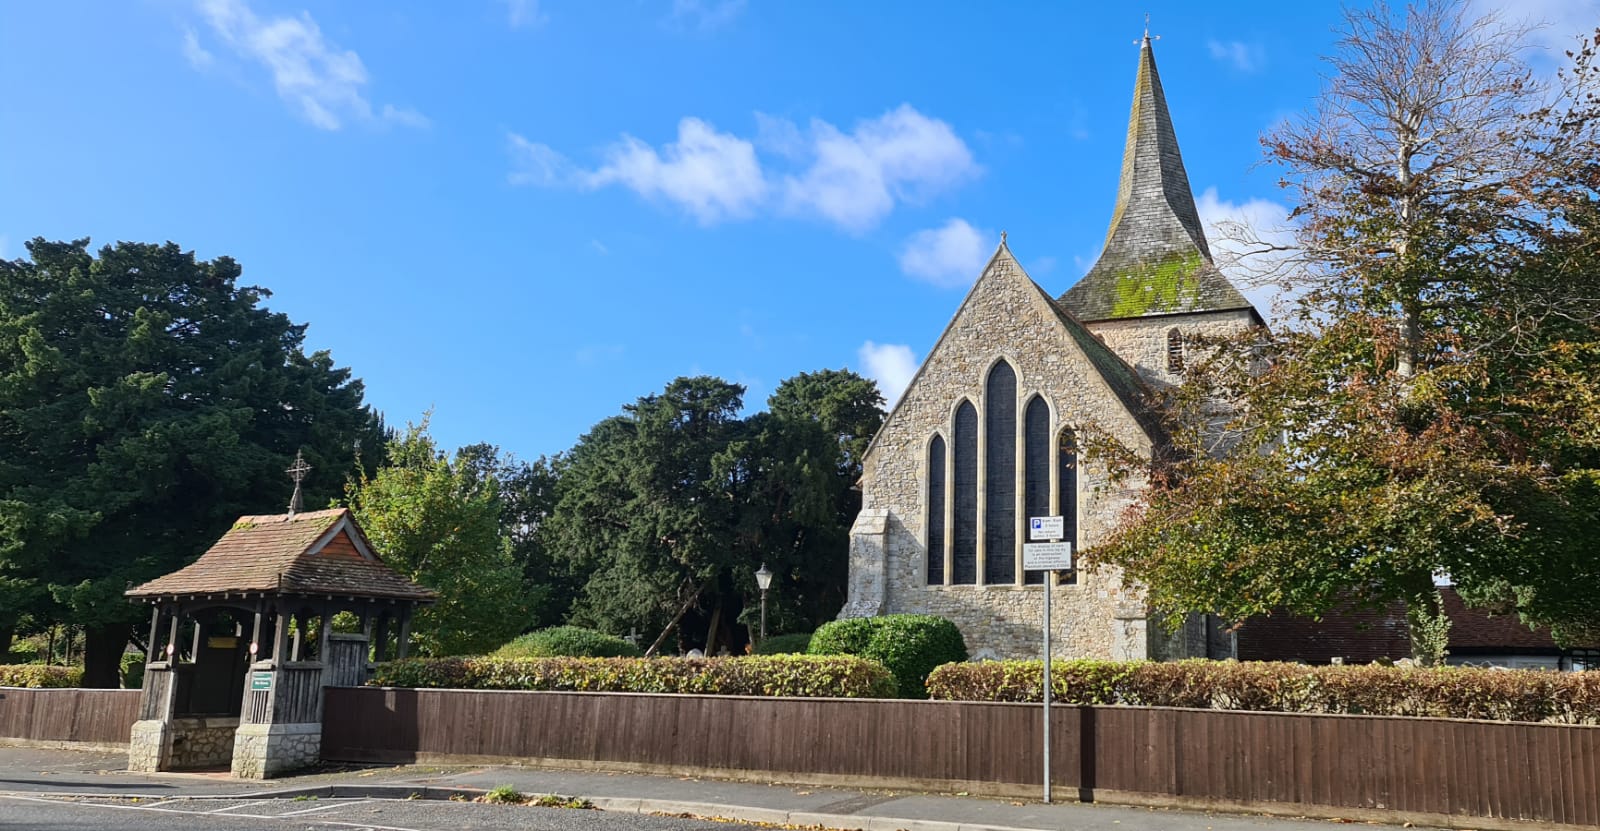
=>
[0,239,382,687]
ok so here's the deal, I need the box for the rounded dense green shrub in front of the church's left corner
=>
[806,615,966,698]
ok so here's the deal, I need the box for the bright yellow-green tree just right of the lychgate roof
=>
[346,420,528,655]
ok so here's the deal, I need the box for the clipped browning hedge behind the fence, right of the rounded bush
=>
[928,661,1600,724]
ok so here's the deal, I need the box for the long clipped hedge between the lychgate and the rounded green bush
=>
[371,655,894,698]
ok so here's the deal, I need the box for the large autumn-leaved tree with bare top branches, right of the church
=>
[1094,0,1600,660]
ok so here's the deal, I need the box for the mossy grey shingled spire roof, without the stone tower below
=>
[1061,34,1253,320]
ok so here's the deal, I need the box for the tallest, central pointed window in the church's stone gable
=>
[984,360,1016,584]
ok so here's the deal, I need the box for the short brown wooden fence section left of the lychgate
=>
[0,687,139,745]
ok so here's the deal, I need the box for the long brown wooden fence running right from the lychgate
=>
[322,687,1600,825]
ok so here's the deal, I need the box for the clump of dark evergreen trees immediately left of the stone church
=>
[539,371,882,653]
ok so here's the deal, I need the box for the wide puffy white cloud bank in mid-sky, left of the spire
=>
[509,104,979,232]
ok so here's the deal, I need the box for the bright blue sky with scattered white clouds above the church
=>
[0,0,1600,456]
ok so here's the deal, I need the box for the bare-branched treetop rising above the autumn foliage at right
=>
[1264,0,1600,376]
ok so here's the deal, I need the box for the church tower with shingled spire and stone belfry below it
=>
[1059,32,1262,386]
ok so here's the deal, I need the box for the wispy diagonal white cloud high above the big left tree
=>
[184,0,426,130]
